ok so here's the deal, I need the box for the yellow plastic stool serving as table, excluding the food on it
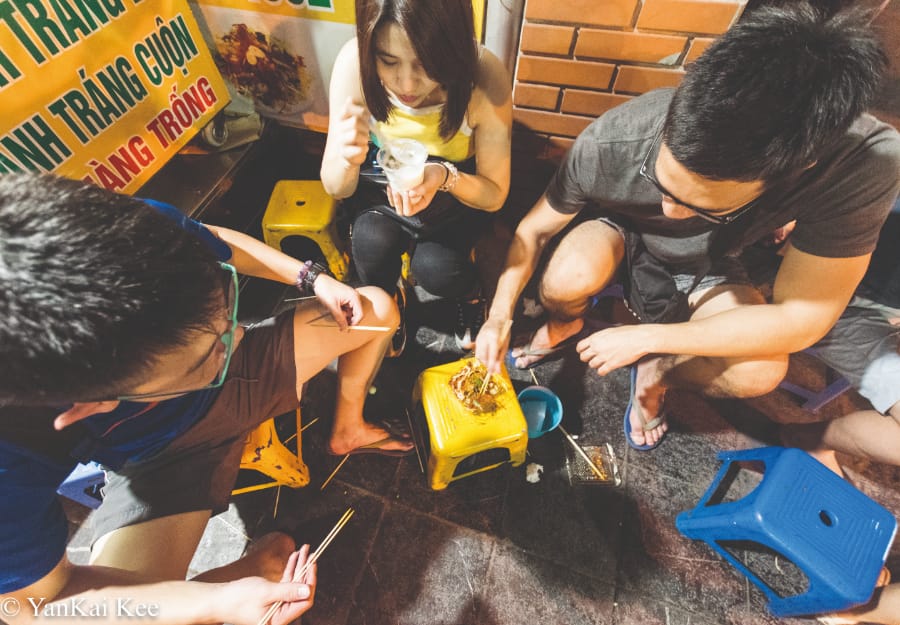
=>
[413,359,528,490]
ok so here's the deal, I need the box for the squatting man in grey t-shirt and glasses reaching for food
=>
[476,2,900,450]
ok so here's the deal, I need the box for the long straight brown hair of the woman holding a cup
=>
[356,0,478,140]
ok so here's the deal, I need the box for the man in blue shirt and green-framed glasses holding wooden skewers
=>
[0,174,411,625]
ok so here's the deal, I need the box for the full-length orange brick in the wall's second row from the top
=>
[575,28,687,63]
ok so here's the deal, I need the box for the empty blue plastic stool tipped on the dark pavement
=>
[675,447,897,617]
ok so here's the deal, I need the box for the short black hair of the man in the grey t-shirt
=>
[664,2,887,183]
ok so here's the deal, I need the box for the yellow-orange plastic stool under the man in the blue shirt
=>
[231,408,309,495]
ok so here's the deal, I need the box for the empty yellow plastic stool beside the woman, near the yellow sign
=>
[262,180,347,280]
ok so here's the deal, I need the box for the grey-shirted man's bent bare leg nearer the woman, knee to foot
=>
[512,220,625,369]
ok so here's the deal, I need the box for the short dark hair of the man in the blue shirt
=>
[0,174,222,405]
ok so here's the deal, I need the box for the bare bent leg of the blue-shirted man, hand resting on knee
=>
[294,287,412,454]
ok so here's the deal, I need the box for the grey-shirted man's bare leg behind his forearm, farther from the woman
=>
[629,285,788,445]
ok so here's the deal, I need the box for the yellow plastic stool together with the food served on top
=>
[413,358,528,490]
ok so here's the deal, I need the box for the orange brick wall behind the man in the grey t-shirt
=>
[513,0,746,159]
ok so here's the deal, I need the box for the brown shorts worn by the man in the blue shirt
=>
[93,310,299,541]
